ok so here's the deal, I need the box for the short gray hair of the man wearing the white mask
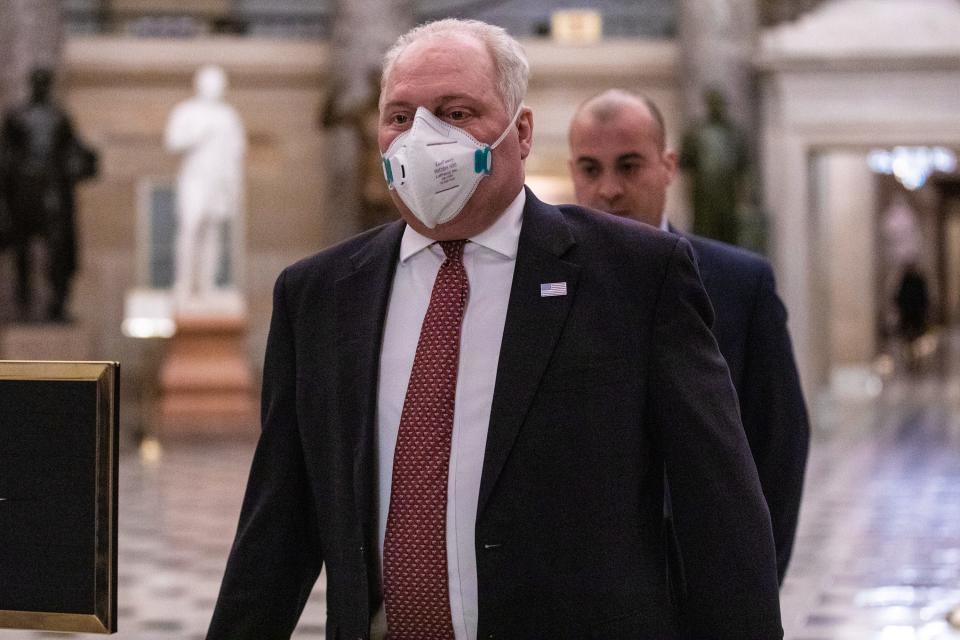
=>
[380,18,530,114]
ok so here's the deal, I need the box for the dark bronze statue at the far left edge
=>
[0,69,97,322]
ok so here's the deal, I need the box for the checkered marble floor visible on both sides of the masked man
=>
[0,345,960,640]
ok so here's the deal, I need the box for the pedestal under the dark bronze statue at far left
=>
[0,322,93,360]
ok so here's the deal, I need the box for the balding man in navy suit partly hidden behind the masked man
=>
[570,89,810,582]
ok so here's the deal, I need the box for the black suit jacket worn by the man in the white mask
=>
[208,191,782,640]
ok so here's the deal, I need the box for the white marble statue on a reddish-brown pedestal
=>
[166,65,246,310]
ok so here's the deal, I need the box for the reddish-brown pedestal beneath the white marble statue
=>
[153,314,259,439]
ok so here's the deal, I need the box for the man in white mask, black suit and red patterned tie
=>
[208,20,782,640]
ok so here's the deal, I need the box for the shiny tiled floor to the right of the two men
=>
[781,374,960,640]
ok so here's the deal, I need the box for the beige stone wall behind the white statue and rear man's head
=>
[54,37,684,422]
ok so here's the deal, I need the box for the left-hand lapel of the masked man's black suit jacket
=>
[335,221,405,548]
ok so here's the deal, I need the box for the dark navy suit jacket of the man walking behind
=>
[682,228,810,582]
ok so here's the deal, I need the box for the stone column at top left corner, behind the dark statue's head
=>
[0,0,63,111]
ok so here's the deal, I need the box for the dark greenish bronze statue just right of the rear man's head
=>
[680,89,749,244]
